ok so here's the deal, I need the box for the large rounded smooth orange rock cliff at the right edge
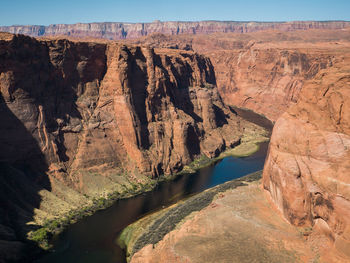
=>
[263,59,350,262]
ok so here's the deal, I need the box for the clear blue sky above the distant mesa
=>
[0,0,350,25]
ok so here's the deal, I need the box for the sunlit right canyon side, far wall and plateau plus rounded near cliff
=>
[127,29,350,262]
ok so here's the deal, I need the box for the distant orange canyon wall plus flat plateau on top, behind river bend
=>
[129,29,350,121]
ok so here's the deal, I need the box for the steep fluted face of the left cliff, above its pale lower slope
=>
[0,33,245,185]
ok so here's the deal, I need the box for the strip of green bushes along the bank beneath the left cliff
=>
[28,127,269,253]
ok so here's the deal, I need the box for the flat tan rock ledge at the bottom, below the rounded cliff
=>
[130,182,317,263]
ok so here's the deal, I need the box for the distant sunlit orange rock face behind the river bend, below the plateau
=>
[206,43,333,121]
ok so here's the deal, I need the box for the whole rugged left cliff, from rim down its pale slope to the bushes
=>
[0,33,256,263]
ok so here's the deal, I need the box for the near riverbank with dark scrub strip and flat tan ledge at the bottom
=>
[123,172,318,263]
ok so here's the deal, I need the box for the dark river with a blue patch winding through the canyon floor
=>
[37,143,268,263]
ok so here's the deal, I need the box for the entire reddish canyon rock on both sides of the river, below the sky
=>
[0,21,350,262]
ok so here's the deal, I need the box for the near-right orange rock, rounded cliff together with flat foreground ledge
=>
[126,42,350,262]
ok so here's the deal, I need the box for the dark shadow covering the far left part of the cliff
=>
[0,35,106,262]
